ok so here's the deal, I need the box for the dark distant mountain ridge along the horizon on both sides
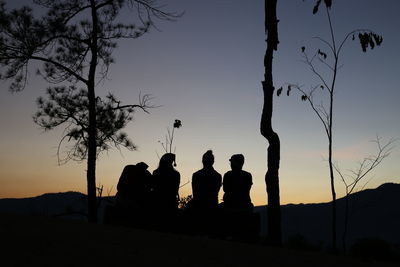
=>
[0,183,400,246]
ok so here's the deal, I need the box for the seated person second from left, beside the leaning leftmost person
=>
[153,153,181,212]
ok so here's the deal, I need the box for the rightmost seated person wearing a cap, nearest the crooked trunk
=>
[223,154,253,211]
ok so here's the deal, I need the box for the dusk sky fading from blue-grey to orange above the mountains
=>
[0,0,400,205]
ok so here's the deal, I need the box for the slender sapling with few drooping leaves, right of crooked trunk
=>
[277,0,383,251]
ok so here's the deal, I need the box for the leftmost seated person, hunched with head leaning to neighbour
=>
[116,162,151,209]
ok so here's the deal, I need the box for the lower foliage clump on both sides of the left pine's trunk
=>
[33,85,153,164]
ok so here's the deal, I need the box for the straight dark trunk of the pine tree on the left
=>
[87,0,98,223]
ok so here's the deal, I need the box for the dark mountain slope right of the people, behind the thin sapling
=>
[256,183,400,246]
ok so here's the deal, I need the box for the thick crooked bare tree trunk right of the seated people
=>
[260,0,282,245]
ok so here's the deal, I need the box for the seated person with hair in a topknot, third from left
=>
[192,150,222,212]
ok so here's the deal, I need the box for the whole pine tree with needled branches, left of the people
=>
[0,0,180,222]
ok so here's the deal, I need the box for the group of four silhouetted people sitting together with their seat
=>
[108,150,253,239]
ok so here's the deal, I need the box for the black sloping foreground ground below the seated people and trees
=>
[0,214,395,267]
